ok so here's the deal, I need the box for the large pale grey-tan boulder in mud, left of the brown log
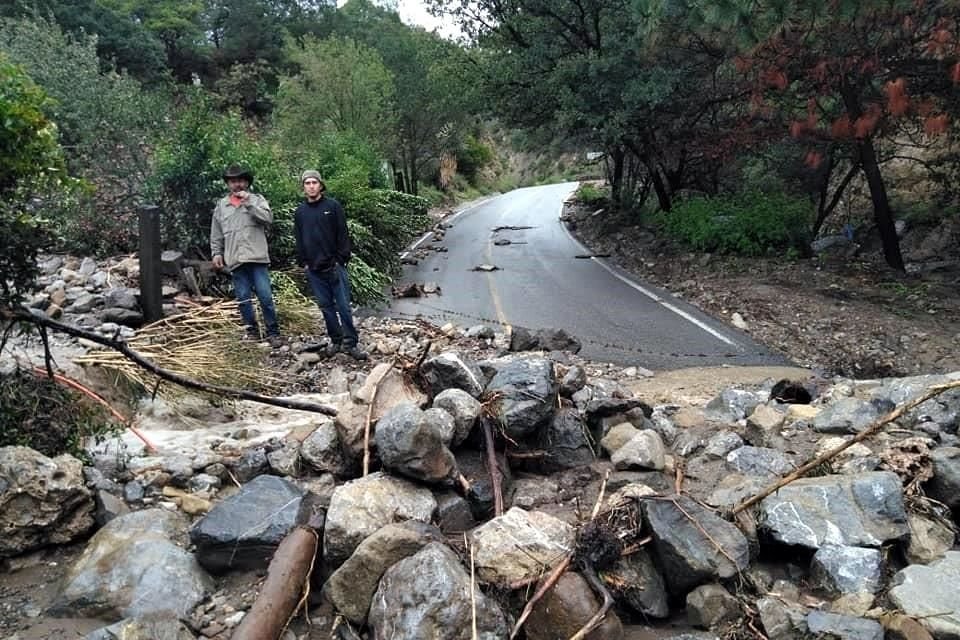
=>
[50,509,214,620]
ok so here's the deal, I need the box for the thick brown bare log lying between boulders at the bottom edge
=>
[232,527,320,640]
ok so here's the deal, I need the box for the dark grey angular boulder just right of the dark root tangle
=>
[641,496,750,595]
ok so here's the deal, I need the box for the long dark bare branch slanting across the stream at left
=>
[5,311,337,416]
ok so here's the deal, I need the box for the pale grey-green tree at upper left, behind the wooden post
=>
[0,19,167,252]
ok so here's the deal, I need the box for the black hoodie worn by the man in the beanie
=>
[293,196,351,271]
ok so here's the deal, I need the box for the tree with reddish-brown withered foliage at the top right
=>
[647,0,960,271]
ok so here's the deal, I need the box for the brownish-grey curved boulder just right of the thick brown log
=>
[323,520,443,626]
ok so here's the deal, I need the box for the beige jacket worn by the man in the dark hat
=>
[210,193,273,271]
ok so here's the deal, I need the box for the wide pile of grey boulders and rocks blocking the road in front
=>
[0,256,960,640]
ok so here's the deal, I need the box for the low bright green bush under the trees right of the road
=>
[656,191,812,256]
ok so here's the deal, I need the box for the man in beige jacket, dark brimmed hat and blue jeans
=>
[210,165,280,344]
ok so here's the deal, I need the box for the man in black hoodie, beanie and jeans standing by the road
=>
[293,169,367,360]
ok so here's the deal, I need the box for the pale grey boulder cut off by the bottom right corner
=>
[889,551,960,640]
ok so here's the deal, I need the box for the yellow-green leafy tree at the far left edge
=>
[0,53,65,310]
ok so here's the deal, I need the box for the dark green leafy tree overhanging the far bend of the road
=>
[433,0,732,210]
